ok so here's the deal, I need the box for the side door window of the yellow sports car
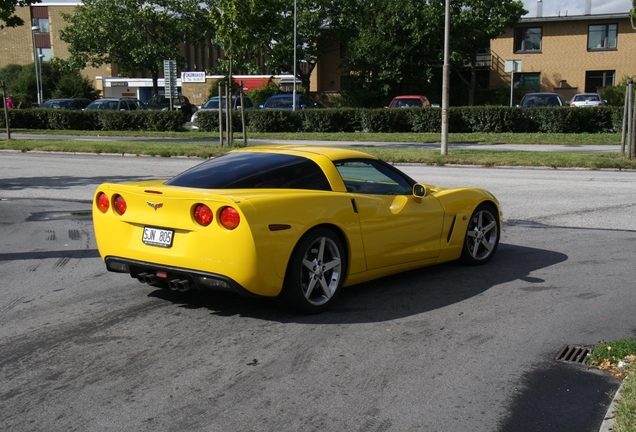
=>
[334,159,413,195]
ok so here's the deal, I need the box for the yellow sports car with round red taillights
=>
[93,145,501,313]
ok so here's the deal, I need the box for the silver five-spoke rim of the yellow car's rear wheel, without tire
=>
[300,237,342,306]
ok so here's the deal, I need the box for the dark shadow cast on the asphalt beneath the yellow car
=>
[149,243,568,324]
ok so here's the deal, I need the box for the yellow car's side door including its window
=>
[335,159,444,270]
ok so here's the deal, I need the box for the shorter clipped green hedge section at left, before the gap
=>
[0,109,185,132]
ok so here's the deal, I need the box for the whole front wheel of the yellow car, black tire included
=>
[461,203,501,265]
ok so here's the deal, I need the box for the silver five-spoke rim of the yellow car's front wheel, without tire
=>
[466,207,499,262]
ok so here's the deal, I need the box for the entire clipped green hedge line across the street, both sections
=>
[0,107,623,133]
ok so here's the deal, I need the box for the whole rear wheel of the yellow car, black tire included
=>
[282,228,346,313]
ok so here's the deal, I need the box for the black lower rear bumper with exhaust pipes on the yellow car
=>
[104,256,261,297]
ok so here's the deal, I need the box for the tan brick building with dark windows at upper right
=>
[490,13,636,100]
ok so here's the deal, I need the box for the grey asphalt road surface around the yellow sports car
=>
[0,152,636,432]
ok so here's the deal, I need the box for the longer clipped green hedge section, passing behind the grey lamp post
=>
[197,107,623,133]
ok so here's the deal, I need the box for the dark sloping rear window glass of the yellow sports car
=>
[166,152,331,191]
